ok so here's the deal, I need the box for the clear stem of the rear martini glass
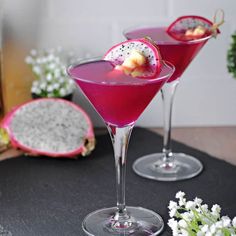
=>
[161,80,179,166]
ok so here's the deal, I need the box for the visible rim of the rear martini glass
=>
[122,23,213,45]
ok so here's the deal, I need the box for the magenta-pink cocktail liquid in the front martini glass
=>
[71,61,169,127]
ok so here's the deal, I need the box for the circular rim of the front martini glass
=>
[66,57,175,86]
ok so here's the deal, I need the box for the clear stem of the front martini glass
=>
[107,124,133,217]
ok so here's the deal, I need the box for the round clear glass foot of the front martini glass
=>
[82,207,164,236]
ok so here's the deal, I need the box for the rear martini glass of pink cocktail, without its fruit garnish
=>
[124,26,211,181]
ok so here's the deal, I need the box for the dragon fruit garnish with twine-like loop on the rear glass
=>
[167,9,224,41]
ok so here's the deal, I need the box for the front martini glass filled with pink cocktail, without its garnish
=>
[68,60,174,236]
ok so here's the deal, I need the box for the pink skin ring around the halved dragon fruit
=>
[1,98,95,158]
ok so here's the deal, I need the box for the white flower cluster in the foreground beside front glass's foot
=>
[168,191,236,236]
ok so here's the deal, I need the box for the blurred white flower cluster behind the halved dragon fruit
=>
[25,48,75,97]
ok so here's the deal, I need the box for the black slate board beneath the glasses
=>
[0,128,236,236]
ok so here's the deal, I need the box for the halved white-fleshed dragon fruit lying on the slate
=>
[1,98,95,157]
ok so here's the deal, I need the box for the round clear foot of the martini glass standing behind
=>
[133,153,203,181]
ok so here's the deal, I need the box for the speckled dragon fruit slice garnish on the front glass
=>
[104,39,162,79]
